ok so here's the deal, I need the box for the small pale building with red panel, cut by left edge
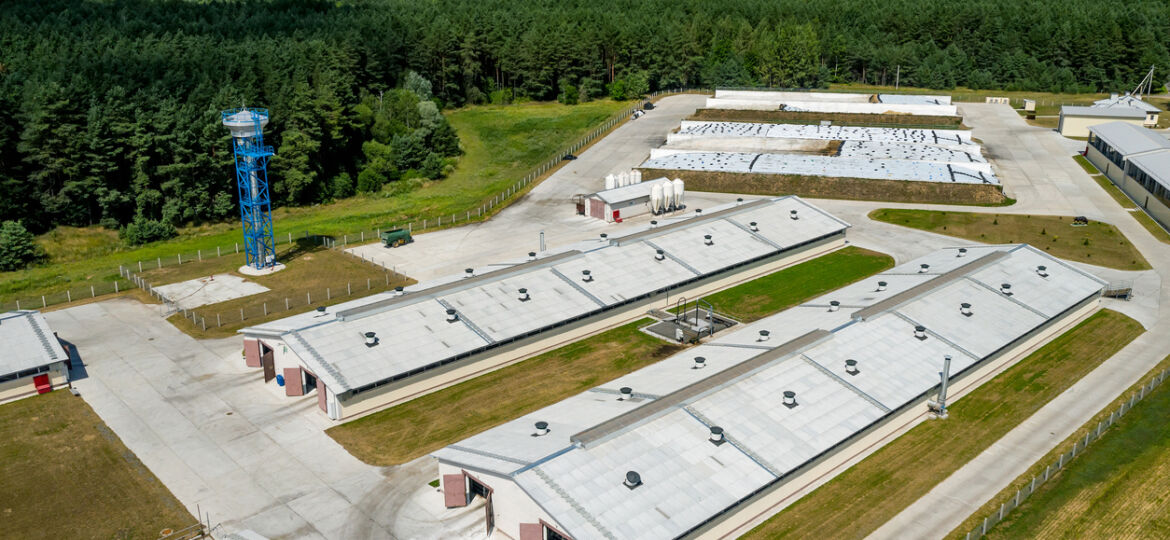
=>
[0,311,69,403]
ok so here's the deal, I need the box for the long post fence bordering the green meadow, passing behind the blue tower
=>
[0,88,710,310]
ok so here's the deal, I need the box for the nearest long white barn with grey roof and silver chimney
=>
[433,244,1104,540]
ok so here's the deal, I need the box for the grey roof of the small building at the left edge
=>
[0,311,69,376]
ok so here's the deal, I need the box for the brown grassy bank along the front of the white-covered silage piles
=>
[642,168,1016,206]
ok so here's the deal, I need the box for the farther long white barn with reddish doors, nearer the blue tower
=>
[241,196,848,420]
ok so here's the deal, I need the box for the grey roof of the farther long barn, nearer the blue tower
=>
[242,196,848,393]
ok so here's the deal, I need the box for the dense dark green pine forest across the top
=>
[0,0,1170,240]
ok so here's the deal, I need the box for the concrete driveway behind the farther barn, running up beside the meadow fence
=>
[350,95,753,281]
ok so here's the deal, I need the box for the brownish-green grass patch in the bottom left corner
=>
[0,390,197,539]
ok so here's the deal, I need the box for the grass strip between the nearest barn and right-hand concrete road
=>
[744,310,1143,539]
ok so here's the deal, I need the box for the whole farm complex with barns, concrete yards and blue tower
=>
[9,85,1170,540]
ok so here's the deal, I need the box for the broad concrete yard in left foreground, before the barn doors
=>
[46,299,484,540]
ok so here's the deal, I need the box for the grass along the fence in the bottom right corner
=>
[948,356,1170,539]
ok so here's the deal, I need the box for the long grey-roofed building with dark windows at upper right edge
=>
[1085,122,1170,229]
